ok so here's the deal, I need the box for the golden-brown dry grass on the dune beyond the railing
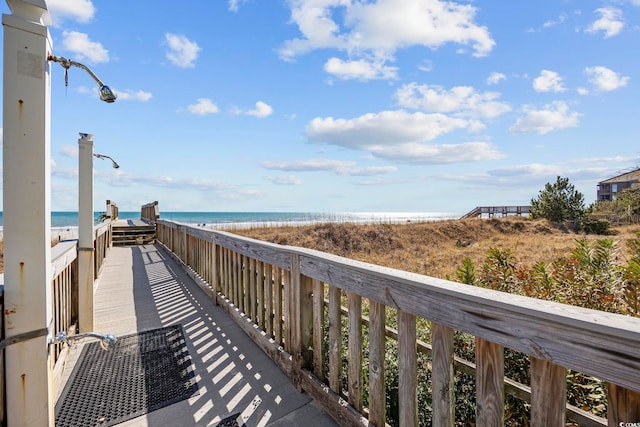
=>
[233,217,640,279]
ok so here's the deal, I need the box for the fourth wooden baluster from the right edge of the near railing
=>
[431,322,455,427]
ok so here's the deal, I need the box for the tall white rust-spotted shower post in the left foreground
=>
[2,0,54,427]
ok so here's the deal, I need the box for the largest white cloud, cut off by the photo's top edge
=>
[280,0,495,78]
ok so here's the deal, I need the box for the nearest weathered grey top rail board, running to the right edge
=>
[297,249,640,391]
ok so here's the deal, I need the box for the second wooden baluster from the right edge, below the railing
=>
[531,357,567,427]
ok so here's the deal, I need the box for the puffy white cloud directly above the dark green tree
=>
[509,101,580,135]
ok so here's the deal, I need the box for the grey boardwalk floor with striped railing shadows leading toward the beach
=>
[56,245,338,427]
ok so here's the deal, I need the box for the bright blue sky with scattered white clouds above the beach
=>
[0,0,640,214]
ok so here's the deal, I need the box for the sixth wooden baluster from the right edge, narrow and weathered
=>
[369,301,386,426]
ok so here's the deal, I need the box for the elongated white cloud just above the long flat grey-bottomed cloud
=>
[395,83,511,118]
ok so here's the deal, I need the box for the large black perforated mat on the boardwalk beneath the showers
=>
[56,325,198,427]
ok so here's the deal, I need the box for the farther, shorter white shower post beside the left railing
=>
[78,133,95,332]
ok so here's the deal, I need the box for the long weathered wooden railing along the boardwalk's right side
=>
[157,220,640,427]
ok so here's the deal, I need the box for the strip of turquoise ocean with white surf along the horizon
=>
[0,211,459,228]
